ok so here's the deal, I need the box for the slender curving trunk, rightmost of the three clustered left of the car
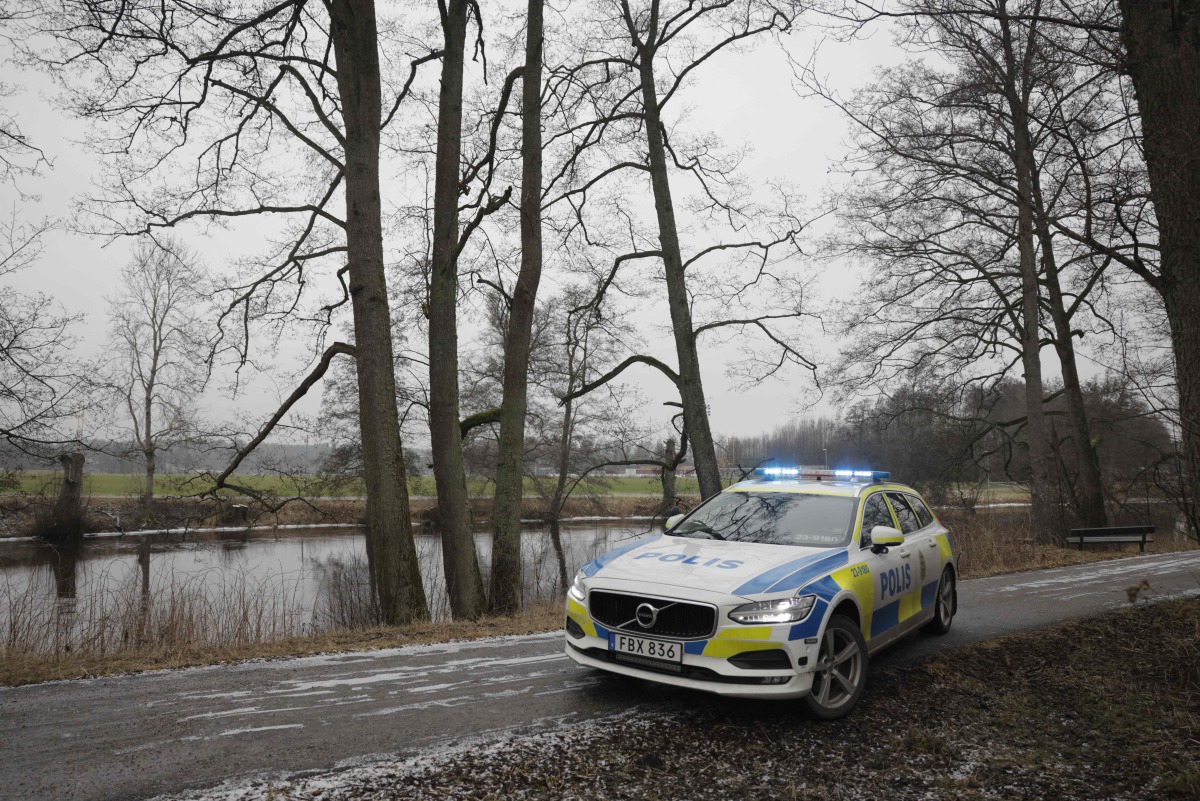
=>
[492,0,542,614]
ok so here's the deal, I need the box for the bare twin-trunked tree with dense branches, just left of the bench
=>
[805,0,1122,540]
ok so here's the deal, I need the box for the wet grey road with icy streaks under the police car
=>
[0,552,1200,801]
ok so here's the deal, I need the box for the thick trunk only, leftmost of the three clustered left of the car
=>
[330,0,428,625]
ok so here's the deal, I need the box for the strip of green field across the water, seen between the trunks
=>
[4,470,698,498]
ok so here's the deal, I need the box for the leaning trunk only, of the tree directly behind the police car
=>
[640,50,721,498]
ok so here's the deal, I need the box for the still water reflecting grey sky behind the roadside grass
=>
[0,522,647,640]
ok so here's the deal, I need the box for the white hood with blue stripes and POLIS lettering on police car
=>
[583,536,850,597]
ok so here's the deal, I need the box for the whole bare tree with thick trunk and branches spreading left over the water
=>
[32,0,438,624]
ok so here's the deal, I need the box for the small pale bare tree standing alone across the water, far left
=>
[108,237,209,504]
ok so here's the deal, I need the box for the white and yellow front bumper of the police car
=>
[565,598,818,699]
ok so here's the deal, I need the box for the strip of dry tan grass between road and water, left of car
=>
[0,602,563,686]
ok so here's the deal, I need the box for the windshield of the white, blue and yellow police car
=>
[667,493,857,548]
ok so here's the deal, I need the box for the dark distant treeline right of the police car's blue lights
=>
[724,377,1178,500]
